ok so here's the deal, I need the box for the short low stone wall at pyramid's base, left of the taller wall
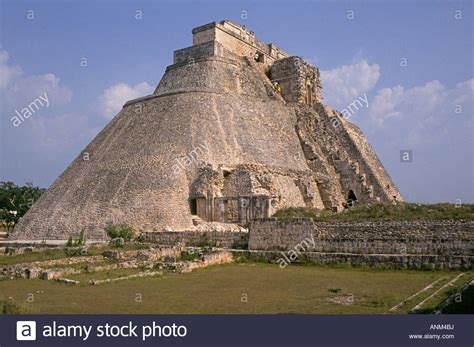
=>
[141,231,249,249]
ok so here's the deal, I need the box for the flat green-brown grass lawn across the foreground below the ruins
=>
[0,263,472,313]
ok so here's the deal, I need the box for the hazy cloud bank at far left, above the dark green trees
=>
[0,50,92,186]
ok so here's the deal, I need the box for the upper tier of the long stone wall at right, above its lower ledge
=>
[249,219,474,255]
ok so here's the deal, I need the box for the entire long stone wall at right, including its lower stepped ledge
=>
[249,219,474,269]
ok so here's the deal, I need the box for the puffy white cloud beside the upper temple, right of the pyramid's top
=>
[321,59,380,109]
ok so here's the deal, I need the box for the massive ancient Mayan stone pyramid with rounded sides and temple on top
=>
[12,21,403,239]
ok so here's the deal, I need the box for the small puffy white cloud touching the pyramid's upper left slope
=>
[99,82,153,119]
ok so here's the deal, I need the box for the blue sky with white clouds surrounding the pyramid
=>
[0,0,474,202]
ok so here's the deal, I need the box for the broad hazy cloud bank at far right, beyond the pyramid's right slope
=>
[357,78,474,202]
